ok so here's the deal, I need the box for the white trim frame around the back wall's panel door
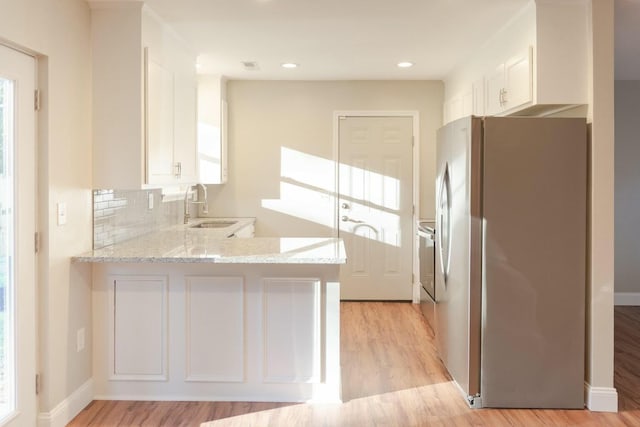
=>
[332,110,420,304]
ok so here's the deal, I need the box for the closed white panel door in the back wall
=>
[338,117,414,300]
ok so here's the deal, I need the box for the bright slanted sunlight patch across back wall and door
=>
[262,147,401,247]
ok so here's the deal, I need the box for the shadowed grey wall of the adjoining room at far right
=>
[615,80,640,293]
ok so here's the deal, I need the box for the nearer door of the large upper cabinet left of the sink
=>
[146,60,174,184]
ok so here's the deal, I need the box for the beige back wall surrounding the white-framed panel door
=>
[209,80,443,236]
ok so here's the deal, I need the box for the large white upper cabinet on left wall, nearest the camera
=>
[90,1,198,189]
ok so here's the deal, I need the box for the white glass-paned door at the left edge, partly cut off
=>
[0,45,37,426]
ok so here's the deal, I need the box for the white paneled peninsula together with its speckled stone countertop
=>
[74,230,346,402]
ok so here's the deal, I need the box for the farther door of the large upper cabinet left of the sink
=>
[173,73,198,183]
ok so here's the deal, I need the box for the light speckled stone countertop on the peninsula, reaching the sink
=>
[71,218,346,264]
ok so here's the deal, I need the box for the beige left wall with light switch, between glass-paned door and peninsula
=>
[0,0,91,418]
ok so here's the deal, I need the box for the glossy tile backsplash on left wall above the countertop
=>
[93,189,184,249]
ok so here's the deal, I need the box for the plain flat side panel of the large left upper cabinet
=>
[90,2,145,189]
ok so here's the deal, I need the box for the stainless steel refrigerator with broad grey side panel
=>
[435,117,584,408]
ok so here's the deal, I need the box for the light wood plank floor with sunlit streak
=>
[69,302,640,427]
